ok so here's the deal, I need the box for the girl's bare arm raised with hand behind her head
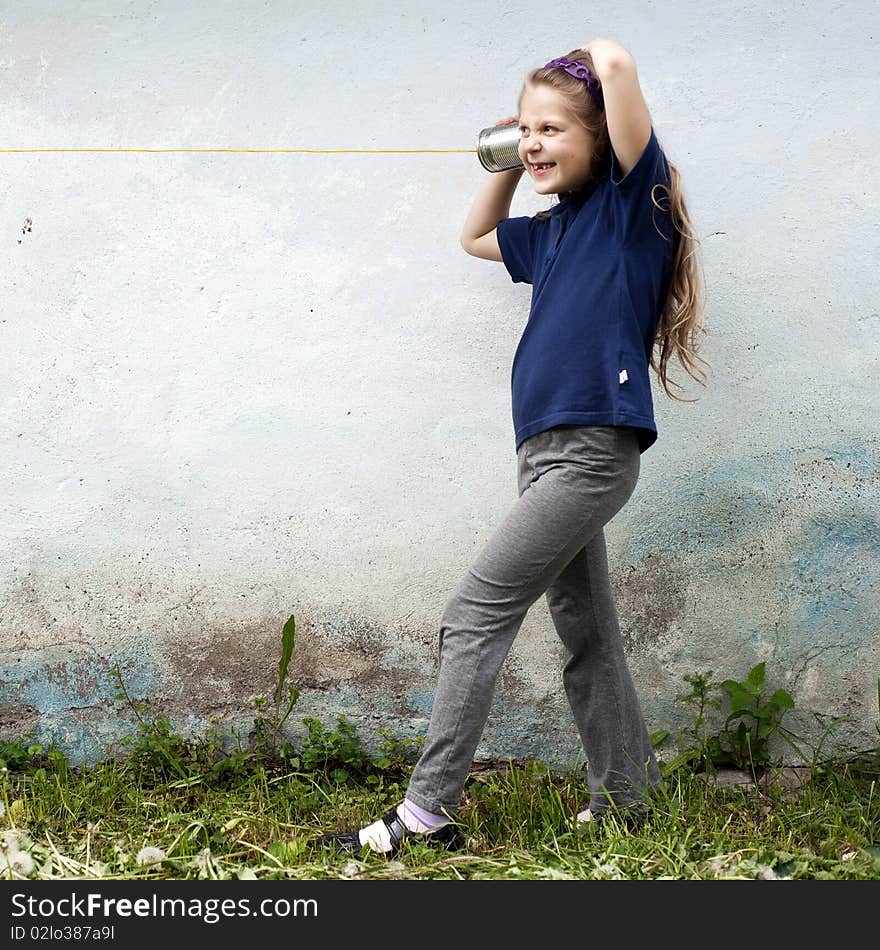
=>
[582,39,651,176]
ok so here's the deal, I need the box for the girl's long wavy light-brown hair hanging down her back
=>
[517,49,709,402]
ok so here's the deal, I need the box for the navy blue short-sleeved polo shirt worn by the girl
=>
[497,128,677,452]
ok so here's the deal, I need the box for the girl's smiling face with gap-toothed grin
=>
[518,85,596,195]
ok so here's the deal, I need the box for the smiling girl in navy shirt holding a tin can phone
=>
[320,39,706,854]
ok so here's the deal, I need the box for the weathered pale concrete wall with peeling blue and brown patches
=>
[0,0,880,763]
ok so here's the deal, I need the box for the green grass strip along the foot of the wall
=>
[0,736,880,880]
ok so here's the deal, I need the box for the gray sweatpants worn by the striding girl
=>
[406,426,661,813]
